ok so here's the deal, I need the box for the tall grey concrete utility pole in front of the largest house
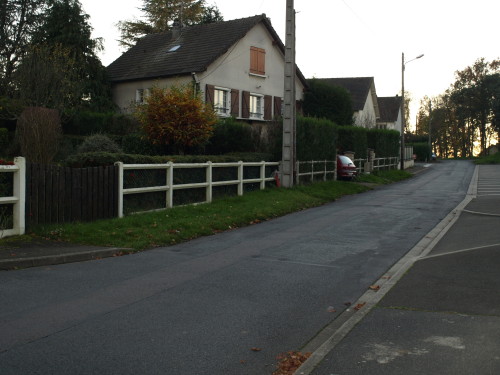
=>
[281,0,296,187]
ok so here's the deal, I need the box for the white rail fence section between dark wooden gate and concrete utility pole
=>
[116,161,279,217]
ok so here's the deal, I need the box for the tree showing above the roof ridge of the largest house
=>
[117,0,223,47]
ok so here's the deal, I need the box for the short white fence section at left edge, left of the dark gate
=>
[0,157,26,238]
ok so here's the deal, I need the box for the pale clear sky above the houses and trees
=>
[80,0,500,124]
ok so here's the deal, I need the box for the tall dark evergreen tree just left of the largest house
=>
[20,0,111,109]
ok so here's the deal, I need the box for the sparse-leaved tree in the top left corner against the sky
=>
[0,0,48,96]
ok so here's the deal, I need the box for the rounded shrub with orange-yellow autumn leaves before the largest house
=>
[135,85,217,154]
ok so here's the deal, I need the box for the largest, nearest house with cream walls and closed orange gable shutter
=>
[107,14,307,121]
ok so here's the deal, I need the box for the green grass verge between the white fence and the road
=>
[0,171,411,251]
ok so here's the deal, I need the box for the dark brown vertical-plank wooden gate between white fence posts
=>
[26,163,118,227]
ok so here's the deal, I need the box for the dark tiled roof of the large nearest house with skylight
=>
[107,14,307,86]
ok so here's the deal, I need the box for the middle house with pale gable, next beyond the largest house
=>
[318,77,380,128]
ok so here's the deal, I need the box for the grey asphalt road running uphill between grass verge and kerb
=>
[0,161,474,375]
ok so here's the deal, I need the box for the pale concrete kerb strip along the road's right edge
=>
[295,166,478,375]
